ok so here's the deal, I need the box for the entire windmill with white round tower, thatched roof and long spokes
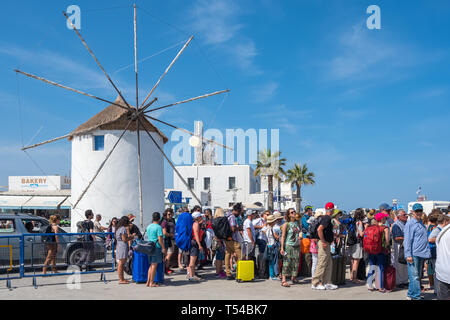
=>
[15,5,229,231]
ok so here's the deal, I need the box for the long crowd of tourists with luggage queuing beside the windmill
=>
[74,202,450,300]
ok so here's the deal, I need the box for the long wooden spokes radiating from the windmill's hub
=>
[15,4,229,228]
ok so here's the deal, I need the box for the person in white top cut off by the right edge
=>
[429,214,450,300]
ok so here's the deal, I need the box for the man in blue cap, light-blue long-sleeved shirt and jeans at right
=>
[403,203,431,300]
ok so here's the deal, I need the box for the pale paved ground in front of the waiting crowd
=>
[0,267,433,300]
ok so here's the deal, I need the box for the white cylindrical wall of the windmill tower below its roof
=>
[70,130,164,232]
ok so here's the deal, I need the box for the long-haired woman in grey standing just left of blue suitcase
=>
[115,216,136,284]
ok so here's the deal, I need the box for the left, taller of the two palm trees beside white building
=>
[254,149,286,210]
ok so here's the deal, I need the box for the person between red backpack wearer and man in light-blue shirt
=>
[391,209,408,289]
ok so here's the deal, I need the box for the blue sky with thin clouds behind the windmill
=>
[0,0,450,209]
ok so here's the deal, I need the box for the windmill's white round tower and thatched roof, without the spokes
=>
[69,98,168,232]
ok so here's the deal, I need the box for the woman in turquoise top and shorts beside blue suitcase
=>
[146,212,167,287]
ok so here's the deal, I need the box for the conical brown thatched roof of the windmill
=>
[69,97,169,143]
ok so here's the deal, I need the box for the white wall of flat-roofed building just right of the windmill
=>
[173,165,264,208]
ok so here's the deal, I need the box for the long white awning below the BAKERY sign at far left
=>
[0,195,71,210]
